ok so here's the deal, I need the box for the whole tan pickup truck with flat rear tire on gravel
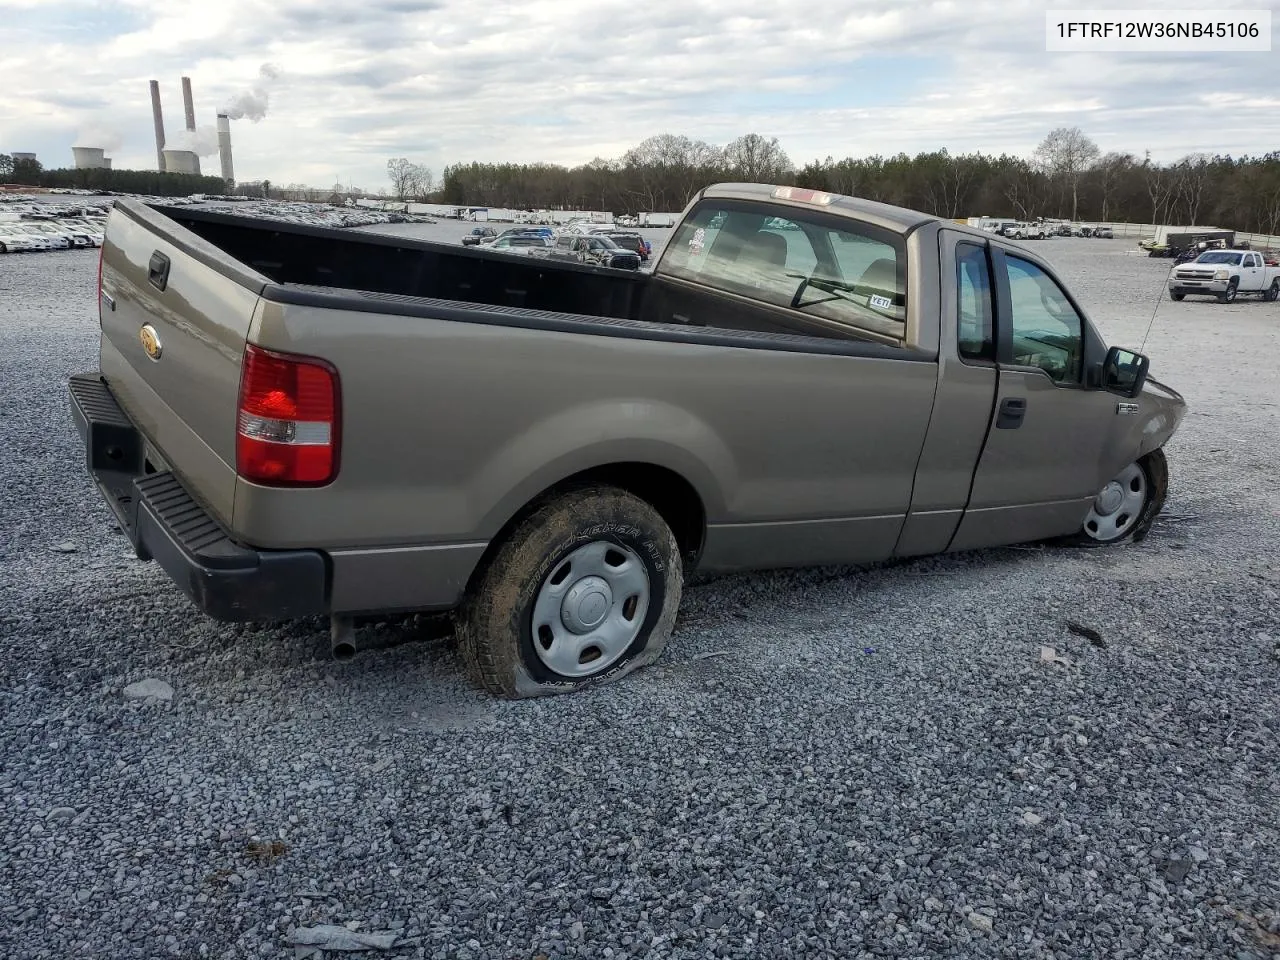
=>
[70,184,1184,696]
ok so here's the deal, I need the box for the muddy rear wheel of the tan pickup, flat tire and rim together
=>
[457,485,684,698]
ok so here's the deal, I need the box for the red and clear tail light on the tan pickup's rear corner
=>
[236,344,339,486]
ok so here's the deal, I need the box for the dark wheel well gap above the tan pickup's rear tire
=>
[468,463,707,586]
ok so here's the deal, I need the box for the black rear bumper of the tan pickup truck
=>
[69,372,330,622]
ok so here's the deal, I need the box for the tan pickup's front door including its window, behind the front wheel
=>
[948,244,1119,550]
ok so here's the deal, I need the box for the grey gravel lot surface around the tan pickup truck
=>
[0,235,1280,960]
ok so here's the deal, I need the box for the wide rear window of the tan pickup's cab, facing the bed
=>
[662,201,906,338]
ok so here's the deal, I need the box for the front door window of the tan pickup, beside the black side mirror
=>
[1005,256,1084,383]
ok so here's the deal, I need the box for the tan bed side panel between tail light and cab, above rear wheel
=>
[233,301,937,607]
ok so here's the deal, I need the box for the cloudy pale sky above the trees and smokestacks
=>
[0,0,1280,189]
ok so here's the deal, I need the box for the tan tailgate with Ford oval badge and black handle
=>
[99,200,268,526]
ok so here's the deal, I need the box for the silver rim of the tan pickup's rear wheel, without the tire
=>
[530,540,649,678]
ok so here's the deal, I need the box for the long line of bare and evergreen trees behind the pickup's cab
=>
[409,127,1280,233]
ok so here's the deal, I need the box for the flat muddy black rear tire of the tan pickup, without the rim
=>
[457,485,684,699]
